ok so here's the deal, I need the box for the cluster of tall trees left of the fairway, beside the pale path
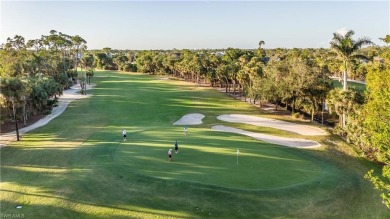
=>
[0,30,93,139]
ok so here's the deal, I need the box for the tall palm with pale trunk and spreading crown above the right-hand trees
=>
[330,30,373,90]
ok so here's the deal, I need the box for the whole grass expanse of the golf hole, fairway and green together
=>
[0,71,390,218]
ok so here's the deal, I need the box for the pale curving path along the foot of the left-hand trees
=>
[0,84,95,148]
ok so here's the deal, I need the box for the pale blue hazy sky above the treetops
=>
[0,0,390,50]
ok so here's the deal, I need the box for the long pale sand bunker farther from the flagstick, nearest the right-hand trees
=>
[217,114,328,135]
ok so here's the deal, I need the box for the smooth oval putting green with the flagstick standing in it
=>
[115,128,326,189]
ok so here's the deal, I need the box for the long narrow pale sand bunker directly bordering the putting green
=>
[211,125,321,148]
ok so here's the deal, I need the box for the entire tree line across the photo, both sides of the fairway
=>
[0,30,390,206]
